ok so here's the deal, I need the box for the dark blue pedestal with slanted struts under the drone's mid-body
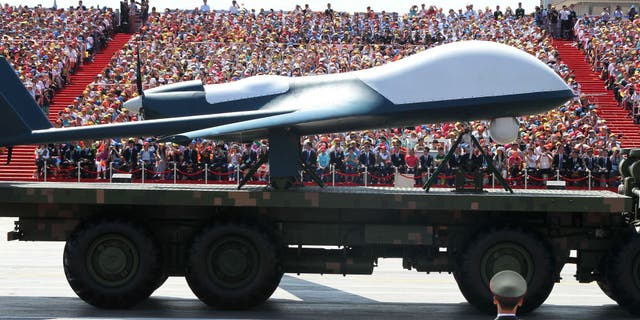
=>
[238,128,324,190]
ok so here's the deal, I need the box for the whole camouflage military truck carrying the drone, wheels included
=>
[0,150,640,314]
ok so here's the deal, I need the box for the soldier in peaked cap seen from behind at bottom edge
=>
[489,270,527,320]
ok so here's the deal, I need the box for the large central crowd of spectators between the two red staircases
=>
[27,3,620,185]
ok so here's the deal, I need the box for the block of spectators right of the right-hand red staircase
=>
[575,6,640,123]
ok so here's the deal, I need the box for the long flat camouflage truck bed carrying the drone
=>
[0,182,632,216]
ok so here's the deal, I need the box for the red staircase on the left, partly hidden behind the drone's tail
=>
[0,33,131,181]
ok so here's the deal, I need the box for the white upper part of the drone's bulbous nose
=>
[358,41,573,116]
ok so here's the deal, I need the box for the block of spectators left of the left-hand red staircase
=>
[0,2,113,111]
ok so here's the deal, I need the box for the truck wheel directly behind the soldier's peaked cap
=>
[454,229,555,314]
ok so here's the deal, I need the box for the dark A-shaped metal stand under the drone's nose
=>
[422,127,513,193]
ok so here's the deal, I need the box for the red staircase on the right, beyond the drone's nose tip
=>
[553,40,640,148]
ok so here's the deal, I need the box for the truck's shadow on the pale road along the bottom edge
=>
[0,275,634,320]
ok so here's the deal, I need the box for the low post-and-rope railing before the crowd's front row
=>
[38,162,620,190]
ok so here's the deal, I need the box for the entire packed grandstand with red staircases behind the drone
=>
[0,3,640,188]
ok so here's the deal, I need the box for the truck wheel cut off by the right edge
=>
[606,235,640,315]
